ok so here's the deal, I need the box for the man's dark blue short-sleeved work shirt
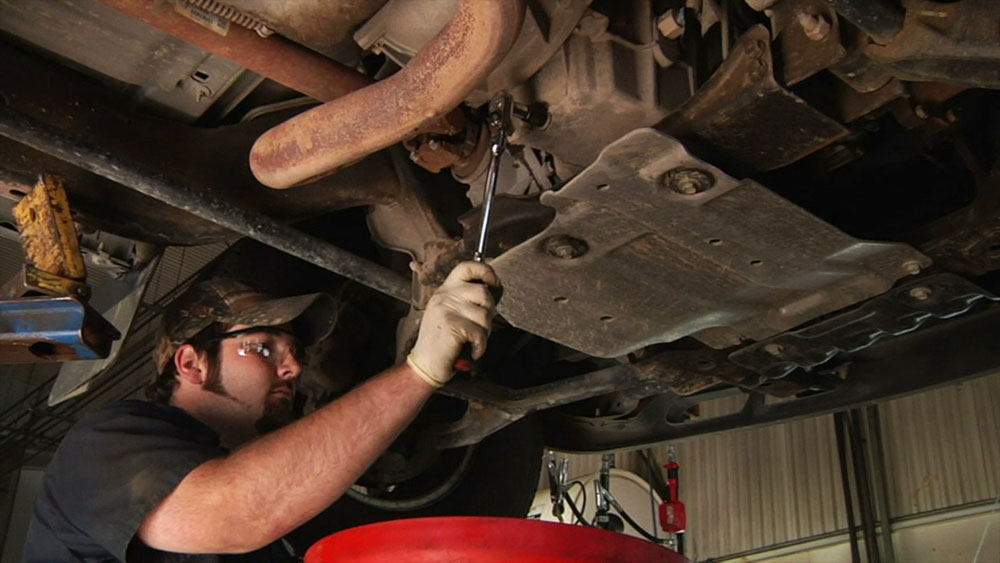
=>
[25,401,294,563]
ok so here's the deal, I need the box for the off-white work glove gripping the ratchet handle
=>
[406,262,500,387]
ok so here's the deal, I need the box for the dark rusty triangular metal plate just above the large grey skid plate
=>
[658,26,847,172]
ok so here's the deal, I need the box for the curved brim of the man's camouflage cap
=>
[219,293,337,346]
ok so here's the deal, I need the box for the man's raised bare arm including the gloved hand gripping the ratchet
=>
[138,262,498,553]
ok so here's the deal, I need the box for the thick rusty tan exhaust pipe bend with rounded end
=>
[250,0,524,189]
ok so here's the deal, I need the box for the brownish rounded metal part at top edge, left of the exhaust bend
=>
[226,0,386,55]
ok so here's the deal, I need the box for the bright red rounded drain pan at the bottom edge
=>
[305,516,689,563]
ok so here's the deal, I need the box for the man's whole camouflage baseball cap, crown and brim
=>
[153,278,337,374]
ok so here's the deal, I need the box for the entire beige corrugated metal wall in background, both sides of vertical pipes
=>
[556,374,1000,560]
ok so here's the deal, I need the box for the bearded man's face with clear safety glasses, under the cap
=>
[203,325,302,434]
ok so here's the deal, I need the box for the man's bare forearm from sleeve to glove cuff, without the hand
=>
[139,365,433,553]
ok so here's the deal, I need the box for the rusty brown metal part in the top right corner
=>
[864,0,1000,89]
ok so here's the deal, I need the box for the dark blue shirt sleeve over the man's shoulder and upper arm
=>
[53,401,226,561]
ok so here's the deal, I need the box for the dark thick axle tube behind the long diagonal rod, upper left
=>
[0,43,399,244]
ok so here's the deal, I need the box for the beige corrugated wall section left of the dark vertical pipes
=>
[677,406,846,559]
